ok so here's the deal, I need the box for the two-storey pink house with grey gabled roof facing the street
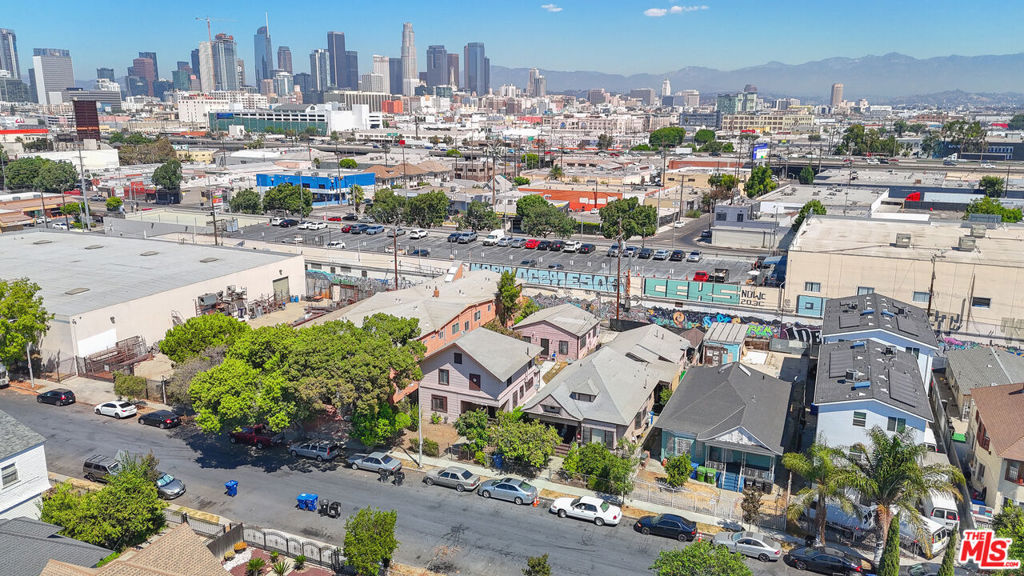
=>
[420,328,541,416]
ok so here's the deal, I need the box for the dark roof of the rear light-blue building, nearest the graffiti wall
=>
[821,292,939,349]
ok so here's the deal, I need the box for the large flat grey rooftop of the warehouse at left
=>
[0,231,302,317]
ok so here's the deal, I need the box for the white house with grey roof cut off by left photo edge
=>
[0,411,50,520]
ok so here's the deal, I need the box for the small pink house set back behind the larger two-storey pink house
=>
[515,304,601,360]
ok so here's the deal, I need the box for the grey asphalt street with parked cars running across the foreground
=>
[0,389,802,576]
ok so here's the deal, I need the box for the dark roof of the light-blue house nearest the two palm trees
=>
[814,340,932,422]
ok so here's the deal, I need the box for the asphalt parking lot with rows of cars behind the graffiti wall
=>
[229,222,754,283]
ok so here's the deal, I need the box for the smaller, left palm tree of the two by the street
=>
[782,442,853,545]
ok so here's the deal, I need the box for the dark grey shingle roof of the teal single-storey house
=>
[654,363,793,454]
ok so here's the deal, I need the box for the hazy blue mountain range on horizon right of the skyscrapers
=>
[490,52,1024,104]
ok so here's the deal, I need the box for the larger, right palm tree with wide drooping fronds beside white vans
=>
[839,426,965,564]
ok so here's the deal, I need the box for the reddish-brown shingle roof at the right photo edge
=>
[971,383,1024,460]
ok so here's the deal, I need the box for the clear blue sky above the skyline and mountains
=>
[0,0,1024,80]
